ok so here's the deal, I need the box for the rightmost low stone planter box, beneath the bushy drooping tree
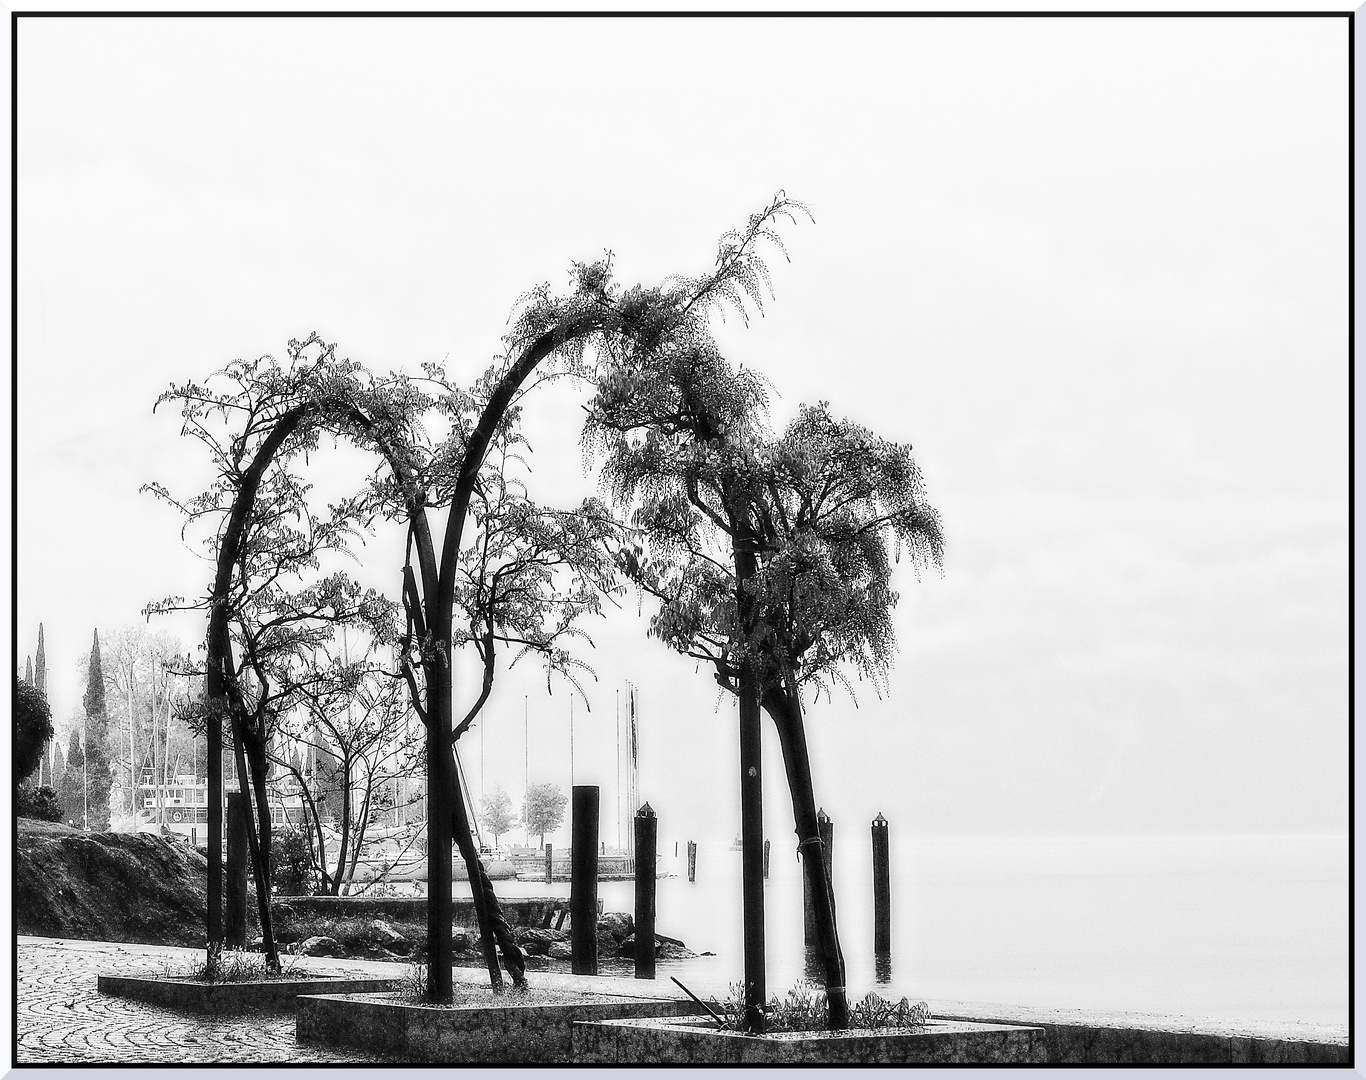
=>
[574,1017,1046,1066]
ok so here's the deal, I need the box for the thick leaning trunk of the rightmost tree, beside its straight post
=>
[764,687,850,1031]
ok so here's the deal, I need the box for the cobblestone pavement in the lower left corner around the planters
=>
[15,938,398,1065]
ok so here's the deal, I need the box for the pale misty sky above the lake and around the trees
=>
[15,18,1348,842]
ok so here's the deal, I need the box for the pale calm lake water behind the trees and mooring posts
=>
[483,837,1348,1024]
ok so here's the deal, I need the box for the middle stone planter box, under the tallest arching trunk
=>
[294,990,697,1065]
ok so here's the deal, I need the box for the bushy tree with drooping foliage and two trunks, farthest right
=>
[586,204,943,1029]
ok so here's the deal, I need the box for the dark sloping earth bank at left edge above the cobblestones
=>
[14,818,224,946]
